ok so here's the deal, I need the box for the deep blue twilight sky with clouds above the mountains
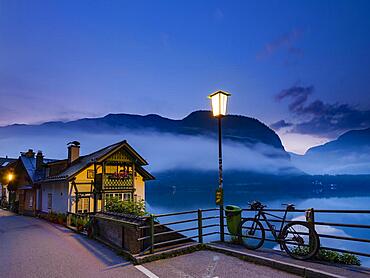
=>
[0,0,370,153]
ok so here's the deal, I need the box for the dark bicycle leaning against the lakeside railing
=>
[239,201,320,260]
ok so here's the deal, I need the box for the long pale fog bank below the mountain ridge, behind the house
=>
[0,127,297,174]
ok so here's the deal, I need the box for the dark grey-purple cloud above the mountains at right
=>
[274,86,370,138]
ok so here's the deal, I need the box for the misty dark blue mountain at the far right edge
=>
[291,128,370,174]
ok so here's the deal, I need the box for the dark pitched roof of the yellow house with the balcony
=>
[45,140,154,181]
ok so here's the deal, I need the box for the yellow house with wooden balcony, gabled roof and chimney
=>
[40,140,154,213]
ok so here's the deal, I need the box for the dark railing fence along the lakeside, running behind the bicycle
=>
[138,205,370,257]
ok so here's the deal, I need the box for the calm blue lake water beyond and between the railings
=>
[147,181,370,266]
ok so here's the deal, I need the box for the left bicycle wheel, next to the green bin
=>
[239,218,265,250]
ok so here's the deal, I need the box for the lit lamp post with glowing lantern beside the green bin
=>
[208,91,231,241]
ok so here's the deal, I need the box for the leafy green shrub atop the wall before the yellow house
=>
[105,197,148,216]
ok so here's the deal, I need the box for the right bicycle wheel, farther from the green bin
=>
[281,222,320,260]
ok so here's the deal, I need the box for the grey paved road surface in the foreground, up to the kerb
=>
[0,210,294,278]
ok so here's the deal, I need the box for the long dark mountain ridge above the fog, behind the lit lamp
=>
[0,111,288,154]
